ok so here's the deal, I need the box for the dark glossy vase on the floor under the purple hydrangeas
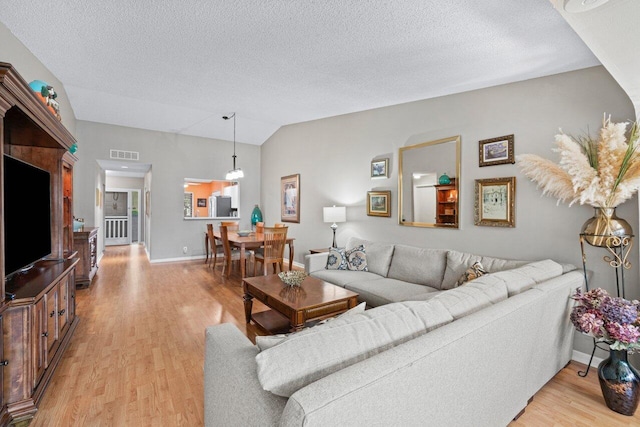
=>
[598,350,640,416]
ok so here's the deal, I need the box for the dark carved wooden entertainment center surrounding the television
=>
[0,62,79,426]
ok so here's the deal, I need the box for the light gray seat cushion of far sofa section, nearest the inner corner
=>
[345,278,437,307]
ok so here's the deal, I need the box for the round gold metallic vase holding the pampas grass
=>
[581,208,633,248]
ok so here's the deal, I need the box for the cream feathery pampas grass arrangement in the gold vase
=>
[516,115,640,208]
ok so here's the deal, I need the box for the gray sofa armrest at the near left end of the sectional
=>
[204,323,287,427]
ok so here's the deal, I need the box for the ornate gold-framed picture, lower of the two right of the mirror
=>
[474,176,516,227]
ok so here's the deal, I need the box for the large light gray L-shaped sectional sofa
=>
[204,239,583,427]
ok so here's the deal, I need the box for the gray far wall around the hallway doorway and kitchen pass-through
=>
[74,120,260,262]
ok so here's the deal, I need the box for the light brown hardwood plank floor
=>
[31,245,640,427]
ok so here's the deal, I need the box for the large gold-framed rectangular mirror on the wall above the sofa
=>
[398,135,460,228]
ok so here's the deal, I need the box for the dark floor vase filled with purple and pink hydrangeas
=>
[570,288,640,415]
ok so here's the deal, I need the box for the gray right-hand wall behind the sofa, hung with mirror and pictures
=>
[261,67,640,358]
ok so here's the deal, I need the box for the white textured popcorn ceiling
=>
[0,0,599,144]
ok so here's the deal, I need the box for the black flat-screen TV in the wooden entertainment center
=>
[4,154,51,277]
